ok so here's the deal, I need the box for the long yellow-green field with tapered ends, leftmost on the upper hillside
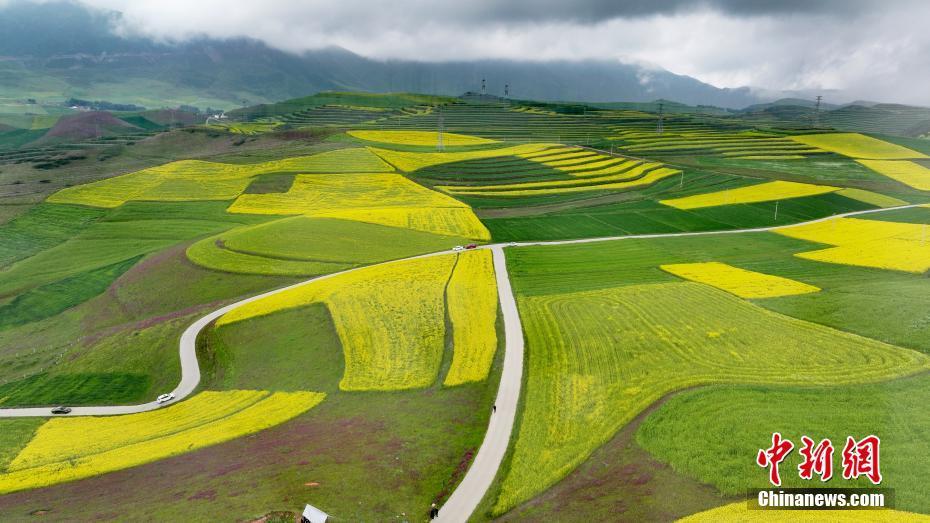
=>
[48,148,393,208]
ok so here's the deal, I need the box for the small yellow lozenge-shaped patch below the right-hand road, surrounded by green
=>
[659,262,820,299]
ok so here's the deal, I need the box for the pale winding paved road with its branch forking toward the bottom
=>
[0,204,925,523]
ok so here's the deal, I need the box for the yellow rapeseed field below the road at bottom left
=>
[0,391,325,493]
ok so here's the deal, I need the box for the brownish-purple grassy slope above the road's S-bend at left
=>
[0,239,293,403]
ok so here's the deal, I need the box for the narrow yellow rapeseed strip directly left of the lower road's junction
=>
[443,249,497,386]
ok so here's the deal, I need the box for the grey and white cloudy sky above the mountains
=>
[63,0,930,105]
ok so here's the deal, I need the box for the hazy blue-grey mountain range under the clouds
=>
[0,2,766,107]
